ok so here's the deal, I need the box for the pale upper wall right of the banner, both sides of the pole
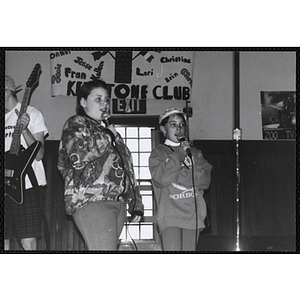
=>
[190,51,296,140]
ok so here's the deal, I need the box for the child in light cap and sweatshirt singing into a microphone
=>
[149,108,212,251]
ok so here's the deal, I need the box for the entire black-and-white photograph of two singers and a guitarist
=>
[4,47,296,253]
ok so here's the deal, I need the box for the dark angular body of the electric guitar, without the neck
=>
[5,141,42,204]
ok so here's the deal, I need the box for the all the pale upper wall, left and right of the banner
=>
[5,50,296,140]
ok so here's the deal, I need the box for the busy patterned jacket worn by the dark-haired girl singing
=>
[57,115,144,216]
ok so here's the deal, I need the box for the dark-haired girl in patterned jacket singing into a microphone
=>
[58,80,144,250]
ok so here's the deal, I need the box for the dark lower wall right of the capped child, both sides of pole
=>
[195,140,296,251]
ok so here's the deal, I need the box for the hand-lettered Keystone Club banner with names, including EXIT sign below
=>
[50,50,194,114]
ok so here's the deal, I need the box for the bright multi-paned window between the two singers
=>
[115,125,154,240]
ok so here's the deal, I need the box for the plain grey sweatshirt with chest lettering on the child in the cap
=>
[149,144,212,231]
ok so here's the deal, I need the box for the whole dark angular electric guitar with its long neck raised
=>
[4,64,42,204]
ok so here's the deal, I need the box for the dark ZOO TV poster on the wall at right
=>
[261,92,296,140]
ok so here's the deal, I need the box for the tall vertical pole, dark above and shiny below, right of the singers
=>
[233,52,242,251]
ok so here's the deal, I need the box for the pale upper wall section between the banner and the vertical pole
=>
[190,52,234,140]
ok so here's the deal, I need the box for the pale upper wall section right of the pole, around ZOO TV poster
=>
[240,52,296,140]
